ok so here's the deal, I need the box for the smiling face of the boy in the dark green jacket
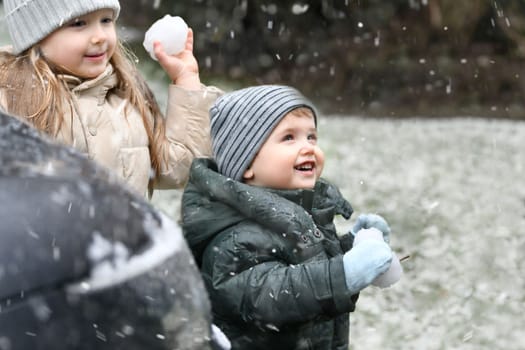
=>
[243,108,324,189]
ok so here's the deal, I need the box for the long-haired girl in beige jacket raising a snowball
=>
[0,0,220,194]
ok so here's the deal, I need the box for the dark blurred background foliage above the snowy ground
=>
[121,0,525,118]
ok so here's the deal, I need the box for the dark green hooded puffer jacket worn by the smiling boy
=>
[182,159,358,350]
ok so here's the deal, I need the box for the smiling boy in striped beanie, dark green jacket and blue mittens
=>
[182,85,392,350]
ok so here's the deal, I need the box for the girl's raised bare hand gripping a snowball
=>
[153,28,201,90]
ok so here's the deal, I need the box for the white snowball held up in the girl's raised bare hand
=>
[142,15,188,61]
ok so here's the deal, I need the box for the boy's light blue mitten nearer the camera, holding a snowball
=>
[343,228,393,294]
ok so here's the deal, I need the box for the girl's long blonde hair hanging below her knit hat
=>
[0,40,165,174]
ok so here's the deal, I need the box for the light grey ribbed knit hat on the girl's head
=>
[4,0,120,54]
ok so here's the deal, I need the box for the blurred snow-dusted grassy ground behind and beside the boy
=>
[153,117,525,350]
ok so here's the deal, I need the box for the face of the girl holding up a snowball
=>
[40,9,117,79]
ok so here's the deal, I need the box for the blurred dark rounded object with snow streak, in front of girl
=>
[0,113,212,350]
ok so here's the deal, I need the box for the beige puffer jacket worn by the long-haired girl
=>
[2,66,222,195]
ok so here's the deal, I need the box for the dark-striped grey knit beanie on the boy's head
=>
[210,85,317,181]
